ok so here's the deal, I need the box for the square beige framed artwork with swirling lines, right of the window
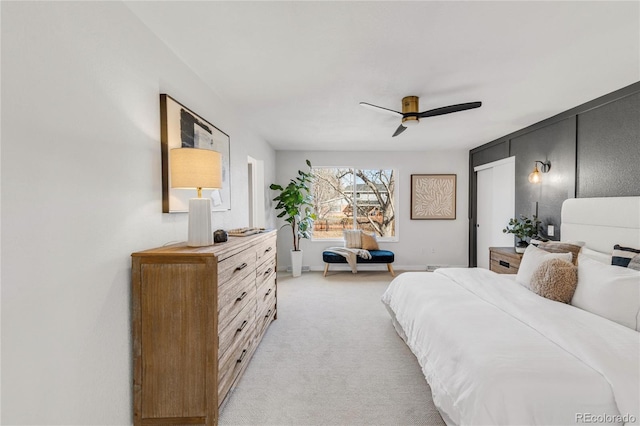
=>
[411,175,456,220]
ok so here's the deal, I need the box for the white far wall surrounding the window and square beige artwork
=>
[276,150,469,270]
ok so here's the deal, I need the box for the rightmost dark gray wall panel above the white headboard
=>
[577,93,640,198]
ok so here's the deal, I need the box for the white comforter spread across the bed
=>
[382,269,640,425]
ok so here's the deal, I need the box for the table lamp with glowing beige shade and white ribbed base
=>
[170,148,222,247]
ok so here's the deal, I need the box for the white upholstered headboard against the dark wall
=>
[560,197,640,253]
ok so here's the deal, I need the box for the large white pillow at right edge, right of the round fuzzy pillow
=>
[571,254,640,331]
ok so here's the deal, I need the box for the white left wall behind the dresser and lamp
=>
[1,2,275,425]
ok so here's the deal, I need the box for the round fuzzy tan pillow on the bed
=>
[531,259,578,303]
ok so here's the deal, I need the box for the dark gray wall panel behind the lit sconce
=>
[505,117,576,240]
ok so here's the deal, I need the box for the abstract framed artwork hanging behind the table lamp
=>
[160,94,231,213]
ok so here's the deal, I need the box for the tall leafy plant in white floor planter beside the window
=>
[269,160,316,277]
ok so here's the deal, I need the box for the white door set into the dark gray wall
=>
[474,157,516,269]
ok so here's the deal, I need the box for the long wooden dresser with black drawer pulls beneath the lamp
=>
[132,231,277,425]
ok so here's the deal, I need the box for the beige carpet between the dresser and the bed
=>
[219,272,444,425]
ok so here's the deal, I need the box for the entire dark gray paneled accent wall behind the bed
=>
[469,82,640,266]
